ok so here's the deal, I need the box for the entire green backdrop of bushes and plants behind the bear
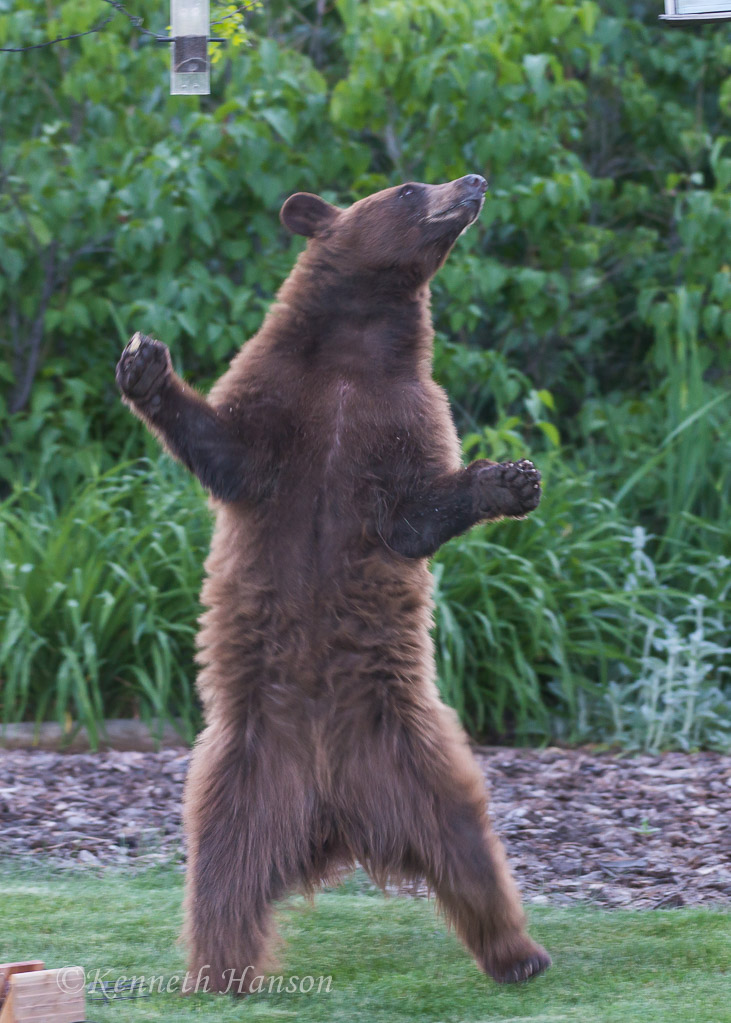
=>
[0,0,731,748]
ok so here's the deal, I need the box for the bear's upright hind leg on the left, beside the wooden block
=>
[182,728,310,994]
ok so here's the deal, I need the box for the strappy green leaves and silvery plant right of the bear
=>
[435,446,731,750]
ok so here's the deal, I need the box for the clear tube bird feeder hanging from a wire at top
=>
[170,0,211,96]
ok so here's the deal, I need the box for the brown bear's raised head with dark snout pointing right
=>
[280,174,488,291]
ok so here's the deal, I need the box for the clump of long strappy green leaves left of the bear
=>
[0,458,210,741]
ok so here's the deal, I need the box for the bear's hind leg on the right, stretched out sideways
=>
[340,705,551,982]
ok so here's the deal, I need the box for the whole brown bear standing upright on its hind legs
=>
[117,174,550,990]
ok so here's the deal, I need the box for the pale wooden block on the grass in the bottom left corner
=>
[0,963,86,1023]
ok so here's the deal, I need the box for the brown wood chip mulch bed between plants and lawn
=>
[0,748,731,908]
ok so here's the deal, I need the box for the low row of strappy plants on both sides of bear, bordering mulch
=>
[0,441,731,749]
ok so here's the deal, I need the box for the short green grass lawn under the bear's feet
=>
[0,865,731,1023]
